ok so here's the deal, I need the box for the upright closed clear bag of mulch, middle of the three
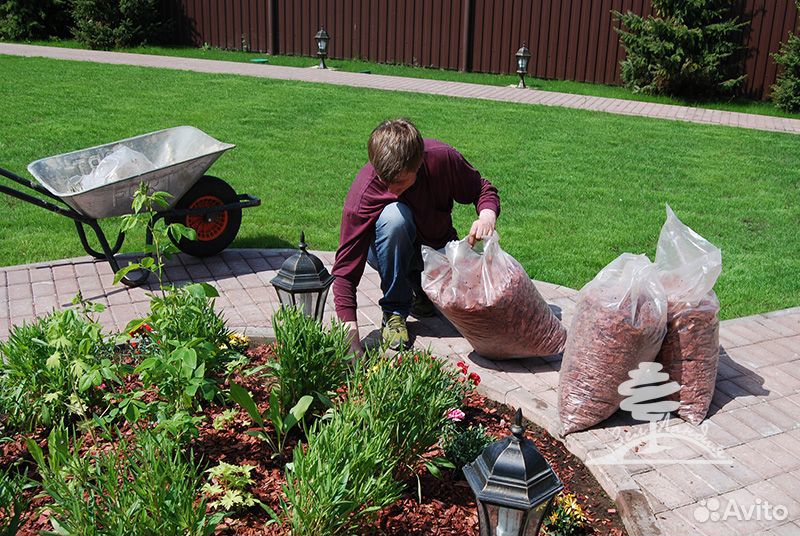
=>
[558,253,667,434]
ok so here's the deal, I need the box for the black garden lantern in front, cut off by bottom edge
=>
[464,410,564,536]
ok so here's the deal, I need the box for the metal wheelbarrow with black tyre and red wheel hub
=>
[0,126,261,286]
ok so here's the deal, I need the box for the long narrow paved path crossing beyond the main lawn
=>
[0,43,800,134]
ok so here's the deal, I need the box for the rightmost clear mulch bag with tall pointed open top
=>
[655,205,722,424]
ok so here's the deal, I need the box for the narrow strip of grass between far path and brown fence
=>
[23,40,800,119]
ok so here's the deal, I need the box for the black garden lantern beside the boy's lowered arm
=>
[270,232,333,322]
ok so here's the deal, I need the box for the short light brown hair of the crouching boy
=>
[367,119,425,184]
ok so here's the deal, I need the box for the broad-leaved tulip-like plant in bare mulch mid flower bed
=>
[231,382,314,458]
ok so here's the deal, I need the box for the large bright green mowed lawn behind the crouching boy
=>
[0,56,800,318]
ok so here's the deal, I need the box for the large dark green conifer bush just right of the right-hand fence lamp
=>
[614,0,745,98]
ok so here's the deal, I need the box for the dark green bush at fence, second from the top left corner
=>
[72,0,165,50]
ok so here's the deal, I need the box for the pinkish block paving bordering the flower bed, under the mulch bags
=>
[0,250,800,536]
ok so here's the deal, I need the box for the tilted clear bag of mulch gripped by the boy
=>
[422,233,566,359]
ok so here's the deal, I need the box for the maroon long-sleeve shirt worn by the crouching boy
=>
[333,139,500,321]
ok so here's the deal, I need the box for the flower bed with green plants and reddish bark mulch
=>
[0,285,623,536]
